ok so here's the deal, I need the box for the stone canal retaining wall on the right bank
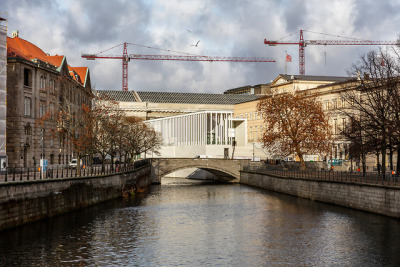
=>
[240,171,400,218]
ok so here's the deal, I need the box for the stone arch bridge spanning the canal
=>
[151,158,251,184]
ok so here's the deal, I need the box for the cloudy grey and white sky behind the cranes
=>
[0,0,400,94]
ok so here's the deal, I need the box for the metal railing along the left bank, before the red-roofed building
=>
[0,160,150,183]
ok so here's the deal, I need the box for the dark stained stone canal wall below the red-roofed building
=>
[0,166,151,231]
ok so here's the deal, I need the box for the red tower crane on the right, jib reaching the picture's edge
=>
[264,30,400,75]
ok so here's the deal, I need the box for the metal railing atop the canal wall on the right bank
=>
[243,166,400,187]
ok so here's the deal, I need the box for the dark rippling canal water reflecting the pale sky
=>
[0,178,400,266]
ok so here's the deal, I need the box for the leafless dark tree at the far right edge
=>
[341,49,400,175]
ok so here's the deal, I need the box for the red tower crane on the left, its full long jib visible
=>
[81,43,275,91]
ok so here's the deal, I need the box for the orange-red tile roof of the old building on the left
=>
[7,37,88,85]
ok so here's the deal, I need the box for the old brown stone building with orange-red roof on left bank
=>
[6,33,93,167]
